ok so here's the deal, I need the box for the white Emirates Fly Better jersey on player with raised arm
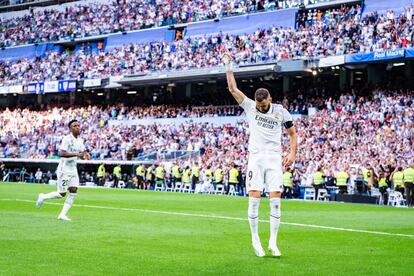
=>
[240,97,292,154]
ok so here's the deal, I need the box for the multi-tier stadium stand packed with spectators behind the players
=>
[0,0,414,206]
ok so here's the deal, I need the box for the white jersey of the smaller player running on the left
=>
[56,134,85,175]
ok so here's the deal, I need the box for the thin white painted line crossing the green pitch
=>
[0,198,414,238]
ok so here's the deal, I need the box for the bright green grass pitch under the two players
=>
[0,183,414,275]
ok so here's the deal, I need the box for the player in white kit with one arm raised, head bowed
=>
[223,53,297,257]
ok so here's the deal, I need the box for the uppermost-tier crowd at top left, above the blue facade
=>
[0,0,326,47]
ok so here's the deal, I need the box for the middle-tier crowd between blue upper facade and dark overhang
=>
[0,5,414,85]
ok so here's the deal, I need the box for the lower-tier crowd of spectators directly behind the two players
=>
[0,89,414,199]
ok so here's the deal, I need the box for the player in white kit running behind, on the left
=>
[36,120,90,221]
